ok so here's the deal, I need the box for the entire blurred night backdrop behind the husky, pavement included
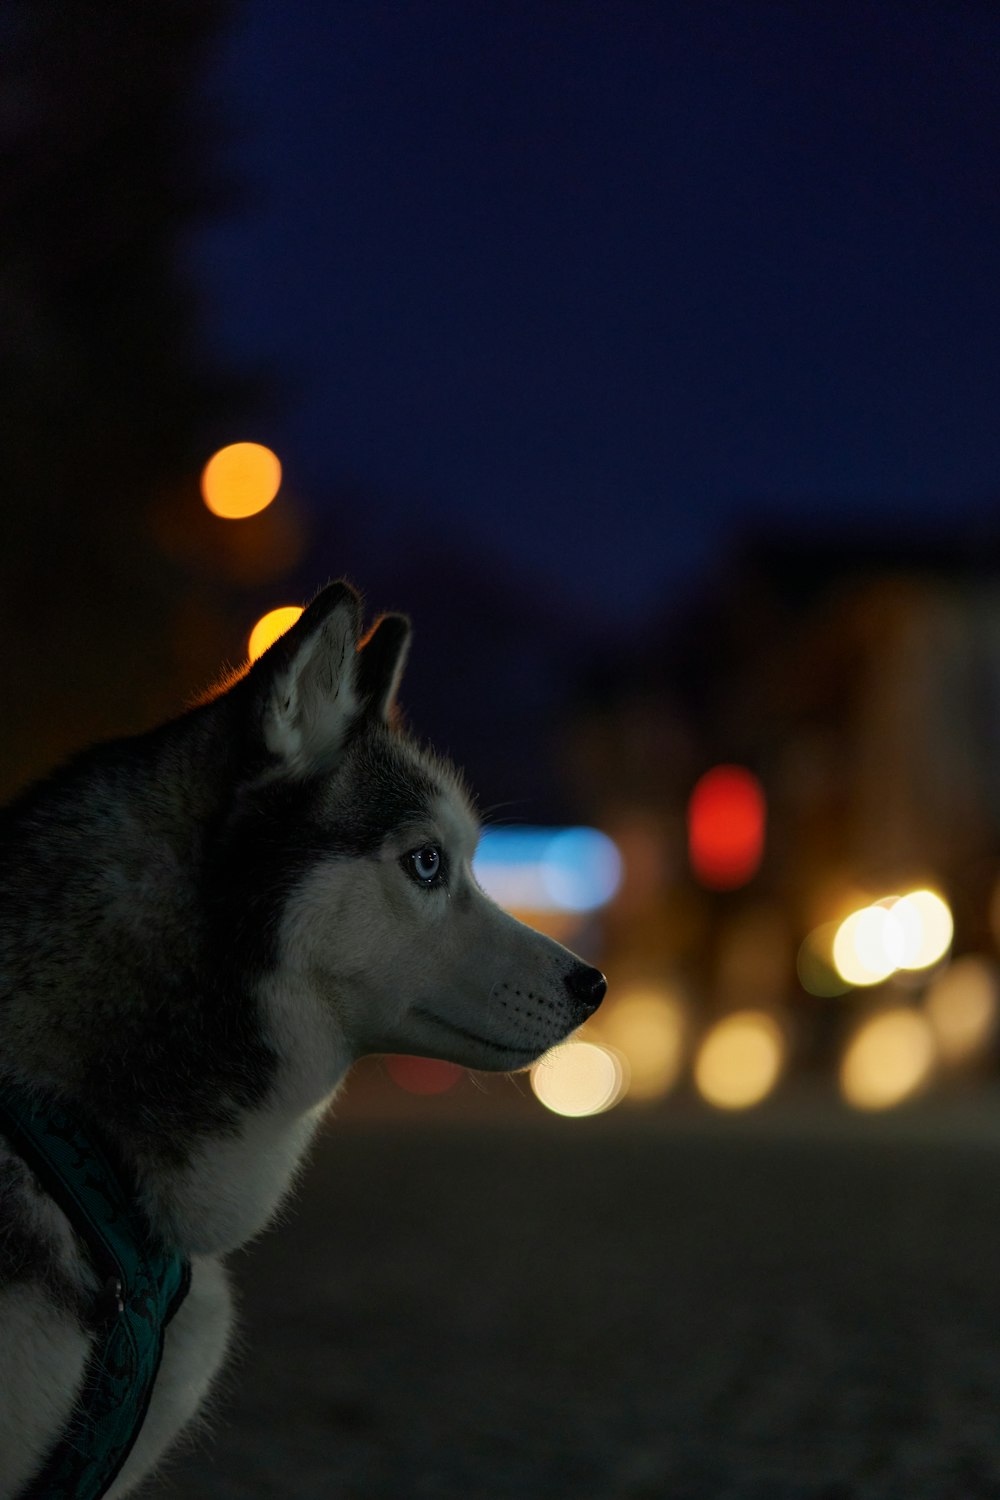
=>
[9,0,1000,1500]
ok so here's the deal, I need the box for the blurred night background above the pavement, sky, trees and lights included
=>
[0,0,1000,1122]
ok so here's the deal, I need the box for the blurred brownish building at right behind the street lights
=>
[565,536,1000,1067]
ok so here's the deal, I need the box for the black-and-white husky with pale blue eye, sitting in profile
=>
[0,582,606,1500]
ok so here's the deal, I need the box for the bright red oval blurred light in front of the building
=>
[688,765,766,891]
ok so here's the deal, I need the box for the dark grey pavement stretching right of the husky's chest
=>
[142,1100,1000,1500]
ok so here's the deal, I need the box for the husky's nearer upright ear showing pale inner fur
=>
[250,581,364,776]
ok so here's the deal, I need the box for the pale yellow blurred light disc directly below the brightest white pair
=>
[840,1008,937,1110]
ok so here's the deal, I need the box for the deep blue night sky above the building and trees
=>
[193,0,1000,633]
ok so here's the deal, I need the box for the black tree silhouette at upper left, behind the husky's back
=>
[0,0,262,792]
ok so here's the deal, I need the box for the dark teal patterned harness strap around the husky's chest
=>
[0,1086,190,1500]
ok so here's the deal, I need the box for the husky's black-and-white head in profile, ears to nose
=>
[226,582,606,1070]
